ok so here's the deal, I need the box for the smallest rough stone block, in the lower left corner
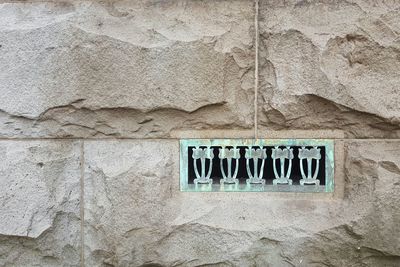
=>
[0,141,81,266]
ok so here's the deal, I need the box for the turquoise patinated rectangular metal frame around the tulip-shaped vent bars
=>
[180,139,334,192]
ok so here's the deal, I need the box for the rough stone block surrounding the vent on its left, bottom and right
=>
[85,141,400,266]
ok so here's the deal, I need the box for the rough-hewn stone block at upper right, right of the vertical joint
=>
[259,0,400,138]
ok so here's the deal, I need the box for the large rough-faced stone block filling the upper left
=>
[0,0,254,137]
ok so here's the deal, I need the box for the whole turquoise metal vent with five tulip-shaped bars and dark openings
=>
[180,139,334,192]
